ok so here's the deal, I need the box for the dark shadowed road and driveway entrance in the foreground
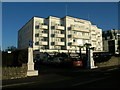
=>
[2,66,120,90]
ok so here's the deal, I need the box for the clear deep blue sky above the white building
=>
[2,2,118,50]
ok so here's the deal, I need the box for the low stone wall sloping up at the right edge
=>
[96,56,120,67]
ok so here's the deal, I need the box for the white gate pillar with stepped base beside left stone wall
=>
[27,47,38,76]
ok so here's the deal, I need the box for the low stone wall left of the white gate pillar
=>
[2,64,27,80]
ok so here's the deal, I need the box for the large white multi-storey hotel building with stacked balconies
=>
[18,16,103,52]
